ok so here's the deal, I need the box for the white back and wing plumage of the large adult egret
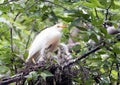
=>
[26,26,62,62]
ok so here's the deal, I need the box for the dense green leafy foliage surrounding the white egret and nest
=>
[0,0,120,85]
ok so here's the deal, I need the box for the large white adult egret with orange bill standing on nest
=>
[26,23,66,64]
